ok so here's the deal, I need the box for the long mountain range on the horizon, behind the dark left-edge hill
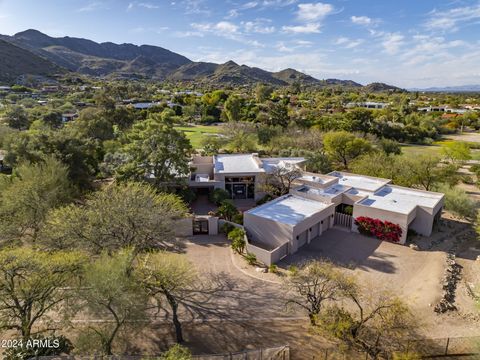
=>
[0,29,398,91]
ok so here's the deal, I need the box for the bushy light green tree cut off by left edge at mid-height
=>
[0,158,74,245]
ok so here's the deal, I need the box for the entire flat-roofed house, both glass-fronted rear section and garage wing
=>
[189,154,444,265]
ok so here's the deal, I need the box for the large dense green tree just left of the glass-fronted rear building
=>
[117,114,192,186]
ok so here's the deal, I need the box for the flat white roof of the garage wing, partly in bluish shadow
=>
[247,195,332,225]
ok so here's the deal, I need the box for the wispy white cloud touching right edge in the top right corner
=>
[424,3,480,31]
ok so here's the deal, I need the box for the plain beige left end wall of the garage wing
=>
[243,212,293,252]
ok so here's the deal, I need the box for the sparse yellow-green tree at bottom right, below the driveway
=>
[317,287,416,359]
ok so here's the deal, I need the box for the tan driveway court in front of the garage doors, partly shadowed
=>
[279,228,445,313]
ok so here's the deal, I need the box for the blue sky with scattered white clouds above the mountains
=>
[0,0,480,88]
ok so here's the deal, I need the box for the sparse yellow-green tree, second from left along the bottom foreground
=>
[77,250,147,355]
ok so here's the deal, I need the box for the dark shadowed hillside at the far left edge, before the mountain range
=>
[0,40,64,82]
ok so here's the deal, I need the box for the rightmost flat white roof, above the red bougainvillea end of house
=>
[359,185,443,214]
